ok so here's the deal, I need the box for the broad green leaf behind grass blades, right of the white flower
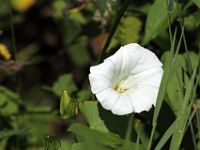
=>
[162,52,198,115]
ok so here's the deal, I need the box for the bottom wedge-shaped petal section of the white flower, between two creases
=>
[111,94,133,115]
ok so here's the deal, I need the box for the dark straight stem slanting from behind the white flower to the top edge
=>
[97,0,131,64]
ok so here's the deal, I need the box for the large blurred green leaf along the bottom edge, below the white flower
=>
[68,123,143,150]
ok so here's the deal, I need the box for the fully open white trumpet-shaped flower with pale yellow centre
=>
[89,43,163,115]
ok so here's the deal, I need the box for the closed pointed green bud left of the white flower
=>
[60,91,78,119]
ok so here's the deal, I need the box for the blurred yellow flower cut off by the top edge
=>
[11,0,36,12]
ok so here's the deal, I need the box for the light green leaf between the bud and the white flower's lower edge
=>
[79,101,108,132]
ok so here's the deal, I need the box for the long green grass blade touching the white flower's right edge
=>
[147,30,177,150]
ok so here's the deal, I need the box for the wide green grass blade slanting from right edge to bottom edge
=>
[170,53,199,150]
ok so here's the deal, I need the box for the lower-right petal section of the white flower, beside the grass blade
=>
[127,90,153,113]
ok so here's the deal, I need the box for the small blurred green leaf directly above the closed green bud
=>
[52,74,77,96]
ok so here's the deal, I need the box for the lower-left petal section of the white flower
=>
[96,88,120,110]
